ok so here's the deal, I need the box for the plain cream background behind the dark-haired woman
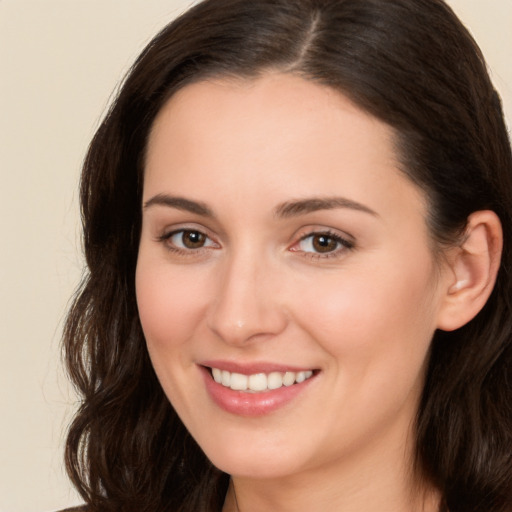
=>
[0,0,512,512]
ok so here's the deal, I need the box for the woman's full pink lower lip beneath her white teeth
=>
[200,366,316,417]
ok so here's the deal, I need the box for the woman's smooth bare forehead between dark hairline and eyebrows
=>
[144,73,419,226]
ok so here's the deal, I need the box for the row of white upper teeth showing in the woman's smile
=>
[211,368,313,392]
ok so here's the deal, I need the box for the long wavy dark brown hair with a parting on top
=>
[64,0,512,512]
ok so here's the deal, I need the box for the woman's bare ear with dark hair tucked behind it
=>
[437,210,503,331]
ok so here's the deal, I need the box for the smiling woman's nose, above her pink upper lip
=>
[207,251,288,346]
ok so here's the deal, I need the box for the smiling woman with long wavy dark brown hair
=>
[65,0,512,512]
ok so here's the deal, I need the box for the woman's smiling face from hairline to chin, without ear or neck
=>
[136,74,452,478]
